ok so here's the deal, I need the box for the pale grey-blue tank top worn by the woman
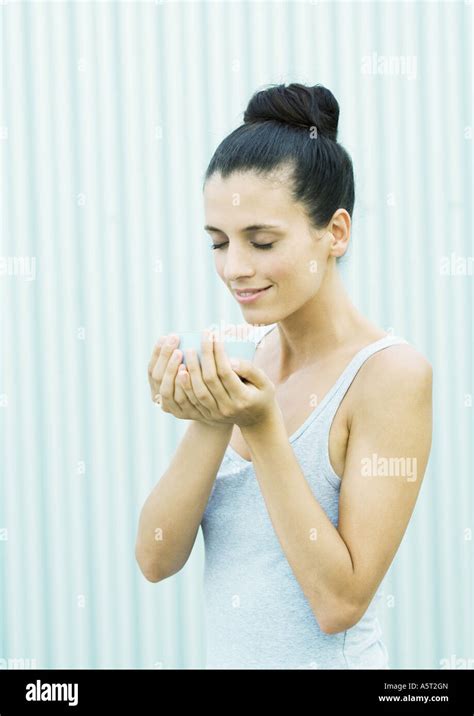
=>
[201,324,407,669]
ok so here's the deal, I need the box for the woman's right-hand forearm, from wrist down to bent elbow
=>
[242,410,354,625]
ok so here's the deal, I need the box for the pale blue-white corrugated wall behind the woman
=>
[0,2,474,668]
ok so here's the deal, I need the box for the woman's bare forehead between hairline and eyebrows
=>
[204,171,298,226]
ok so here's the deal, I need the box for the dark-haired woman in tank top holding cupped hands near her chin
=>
[136,84,432,669]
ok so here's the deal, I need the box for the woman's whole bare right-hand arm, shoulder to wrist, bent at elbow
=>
[242,346,432,634]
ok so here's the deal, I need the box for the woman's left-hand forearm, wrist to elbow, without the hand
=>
[135,421,233,581]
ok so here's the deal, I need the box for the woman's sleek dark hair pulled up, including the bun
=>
[204,83,354,261]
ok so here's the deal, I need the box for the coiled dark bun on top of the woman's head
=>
[244,82,339,141]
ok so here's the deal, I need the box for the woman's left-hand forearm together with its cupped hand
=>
[135,324,265,582]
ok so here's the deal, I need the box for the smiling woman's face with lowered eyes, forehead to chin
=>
[204,170,340,324]
